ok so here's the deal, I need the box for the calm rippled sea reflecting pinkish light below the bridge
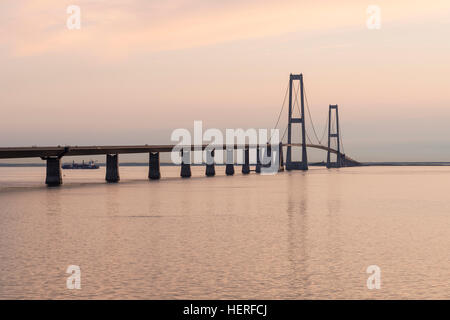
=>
[0,167,450,299]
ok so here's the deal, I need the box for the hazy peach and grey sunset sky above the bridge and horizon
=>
[0,0,450,161]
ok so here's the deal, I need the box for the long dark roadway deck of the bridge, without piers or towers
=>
[0,143,357,163]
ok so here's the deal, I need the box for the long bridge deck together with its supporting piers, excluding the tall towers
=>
[0,143,359,186]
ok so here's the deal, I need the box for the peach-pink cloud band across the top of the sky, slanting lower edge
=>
[0,0,449,59]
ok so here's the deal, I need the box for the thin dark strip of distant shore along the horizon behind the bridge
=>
[0,161,450,168]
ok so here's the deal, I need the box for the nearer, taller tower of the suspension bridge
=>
[286,74,308,170]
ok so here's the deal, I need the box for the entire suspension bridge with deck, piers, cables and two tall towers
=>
[0,74,360,186]
